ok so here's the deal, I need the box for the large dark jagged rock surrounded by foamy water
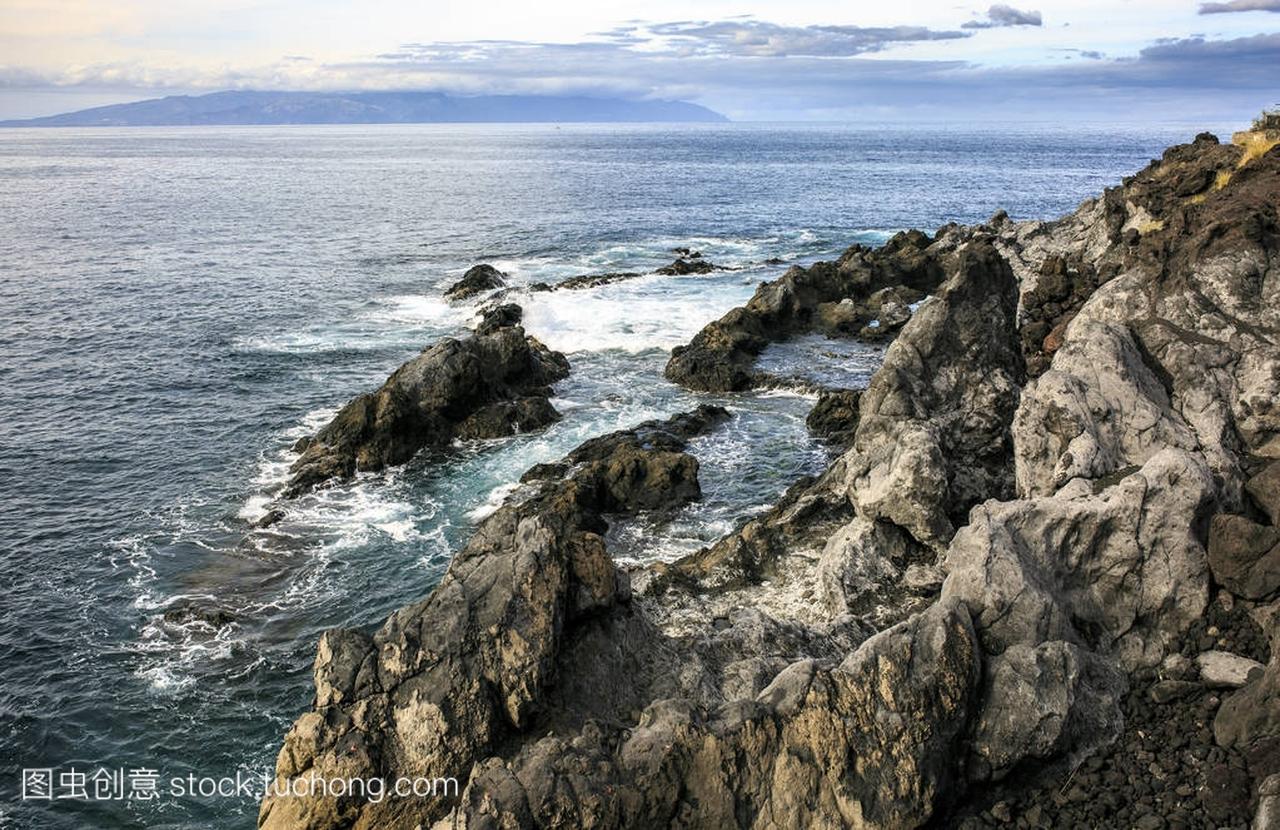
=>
[293,305,568,498]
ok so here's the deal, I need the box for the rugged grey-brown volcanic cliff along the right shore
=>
[260,136,1280,827]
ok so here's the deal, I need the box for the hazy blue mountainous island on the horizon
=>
[0,91,728,127]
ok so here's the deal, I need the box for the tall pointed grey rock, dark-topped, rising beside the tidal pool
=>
[842,242,1023,549]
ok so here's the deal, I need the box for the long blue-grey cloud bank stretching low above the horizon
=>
[0,19,1280,120]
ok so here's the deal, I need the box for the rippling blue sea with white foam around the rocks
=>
[0,124,1218,829]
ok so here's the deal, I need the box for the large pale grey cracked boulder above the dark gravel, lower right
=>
[942,448,1215,671]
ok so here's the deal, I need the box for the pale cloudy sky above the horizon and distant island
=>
[0,0,1280,122]
